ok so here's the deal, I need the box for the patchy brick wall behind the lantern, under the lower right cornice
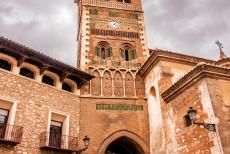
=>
[164,80,222,154]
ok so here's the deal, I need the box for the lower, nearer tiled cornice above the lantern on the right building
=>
[161,63,230,103]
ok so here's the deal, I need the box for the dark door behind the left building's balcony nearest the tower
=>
[49,121,62,148]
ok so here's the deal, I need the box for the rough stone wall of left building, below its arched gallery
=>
[0,70,80,154]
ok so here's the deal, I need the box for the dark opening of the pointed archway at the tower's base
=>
[105,137,144,154]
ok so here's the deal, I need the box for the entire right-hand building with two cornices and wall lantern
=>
[139,49,230,154]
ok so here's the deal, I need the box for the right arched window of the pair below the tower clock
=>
[120,43,137,61]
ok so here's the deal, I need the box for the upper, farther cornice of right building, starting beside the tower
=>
[139,49,215,77]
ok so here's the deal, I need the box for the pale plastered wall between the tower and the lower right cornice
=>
[145,60,193,154]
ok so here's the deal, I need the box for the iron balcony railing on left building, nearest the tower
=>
[40,132,78,152]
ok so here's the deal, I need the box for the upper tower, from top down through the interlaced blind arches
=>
[76,0,149,98]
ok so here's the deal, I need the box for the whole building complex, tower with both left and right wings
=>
[0,0,230,154]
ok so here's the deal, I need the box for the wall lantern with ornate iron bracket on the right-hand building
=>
[184,107,216,131]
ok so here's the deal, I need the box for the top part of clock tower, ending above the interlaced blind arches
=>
[76,0,149,72]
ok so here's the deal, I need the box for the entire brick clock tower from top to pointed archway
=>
[76,0,149,154]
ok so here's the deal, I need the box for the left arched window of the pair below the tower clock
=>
[95,41,112,59]
